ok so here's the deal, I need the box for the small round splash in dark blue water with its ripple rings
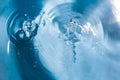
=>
[7,12,38,43]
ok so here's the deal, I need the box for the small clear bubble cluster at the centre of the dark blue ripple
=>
[15,20,38,41]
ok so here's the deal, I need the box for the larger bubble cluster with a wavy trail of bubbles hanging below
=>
[60,14,96,62]
